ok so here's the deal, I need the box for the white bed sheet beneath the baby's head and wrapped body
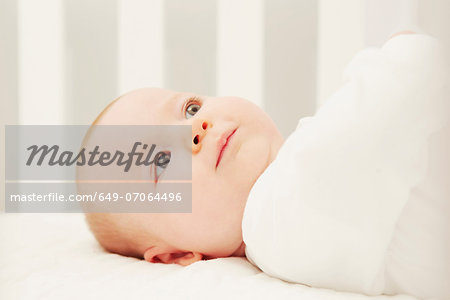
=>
[0,214,415,300]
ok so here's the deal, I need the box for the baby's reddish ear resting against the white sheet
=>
[144,246,203,266]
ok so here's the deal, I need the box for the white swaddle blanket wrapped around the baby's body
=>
[242,34,450,299]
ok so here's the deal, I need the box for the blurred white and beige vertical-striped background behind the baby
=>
[0,0,450,206]
